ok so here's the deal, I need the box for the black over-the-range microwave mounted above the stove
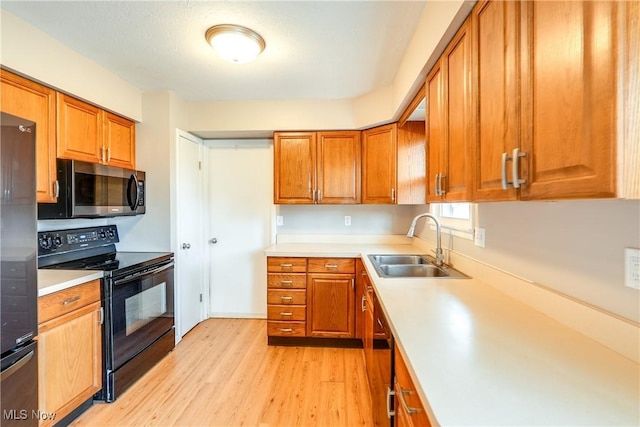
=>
[38,159,145,219]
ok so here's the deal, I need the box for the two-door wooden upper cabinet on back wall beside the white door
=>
[274,131,361,204]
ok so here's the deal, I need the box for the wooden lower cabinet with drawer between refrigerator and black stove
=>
[38,280,102,426]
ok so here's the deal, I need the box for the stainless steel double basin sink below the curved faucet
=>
[369,255,469,279]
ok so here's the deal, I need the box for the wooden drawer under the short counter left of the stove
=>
[38,280,100,323]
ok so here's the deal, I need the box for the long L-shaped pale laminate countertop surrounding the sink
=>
[265,243,640,426]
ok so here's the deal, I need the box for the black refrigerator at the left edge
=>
[0,113,38,427]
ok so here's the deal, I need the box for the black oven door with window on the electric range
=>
[107,261,174,371]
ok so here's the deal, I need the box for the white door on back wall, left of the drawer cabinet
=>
[207,140,273,318]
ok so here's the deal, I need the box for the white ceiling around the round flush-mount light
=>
[0,0,426,101]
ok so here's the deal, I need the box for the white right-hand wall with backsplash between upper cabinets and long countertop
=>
[417,200,640,322]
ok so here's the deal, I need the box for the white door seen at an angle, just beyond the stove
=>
[176,132,206,338]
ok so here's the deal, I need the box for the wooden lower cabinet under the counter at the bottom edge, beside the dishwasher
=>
[394,345,431,427]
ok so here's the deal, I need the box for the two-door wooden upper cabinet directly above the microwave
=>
[57,93,135,169]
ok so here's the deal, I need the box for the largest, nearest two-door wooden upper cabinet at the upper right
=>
[472,1,640,201]
